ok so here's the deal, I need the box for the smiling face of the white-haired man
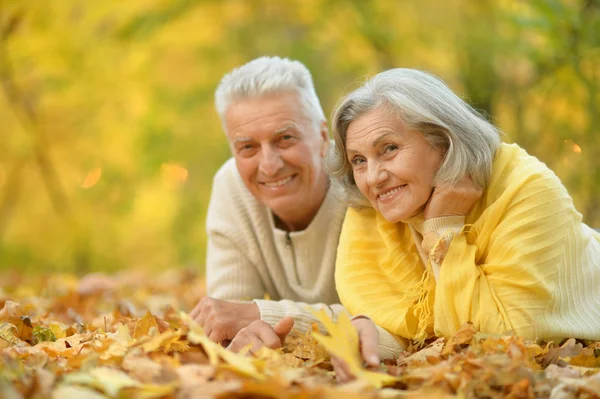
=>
[225,93,328,223]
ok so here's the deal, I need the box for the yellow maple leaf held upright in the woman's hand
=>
[313,309,398,388]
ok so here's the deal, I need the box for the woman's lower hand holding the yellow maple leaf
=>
[331,317,380,382]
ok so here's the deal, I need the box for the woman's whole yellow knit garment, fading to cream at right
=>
[336,144,600,356]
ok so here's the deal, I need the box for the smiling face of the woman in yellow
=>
[346,107,443,223]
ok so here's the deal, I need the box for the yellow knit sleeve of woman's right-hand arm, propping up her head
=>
[434,171,580,339]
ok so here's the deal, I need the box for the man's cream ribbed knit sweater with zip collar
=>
[206,159,346,333]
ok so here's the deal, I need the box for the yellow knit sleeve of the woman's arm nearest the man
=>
[335,208,433,346]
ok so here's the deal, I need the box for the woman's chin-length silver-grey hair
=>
[328,68,500,206]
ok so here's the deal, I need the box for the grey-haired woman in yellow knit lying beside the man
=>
[330,69,600,364]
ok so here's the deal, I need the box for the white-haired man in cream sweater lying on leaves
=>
[191,57,346,350]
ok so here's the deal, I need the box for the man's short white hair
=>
[215,57,326,128]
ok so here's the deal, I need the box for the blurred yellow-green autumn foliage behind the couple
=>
[0,0,600,273]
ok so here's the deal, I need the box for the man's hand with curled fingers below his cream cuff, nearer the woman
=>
[227,317,294,353]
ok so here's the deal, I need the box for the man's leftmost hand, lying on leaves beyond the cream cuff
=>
[190,297,260,342]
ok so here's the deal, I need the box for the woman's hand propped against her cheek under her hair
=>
[423,176,483,220]
